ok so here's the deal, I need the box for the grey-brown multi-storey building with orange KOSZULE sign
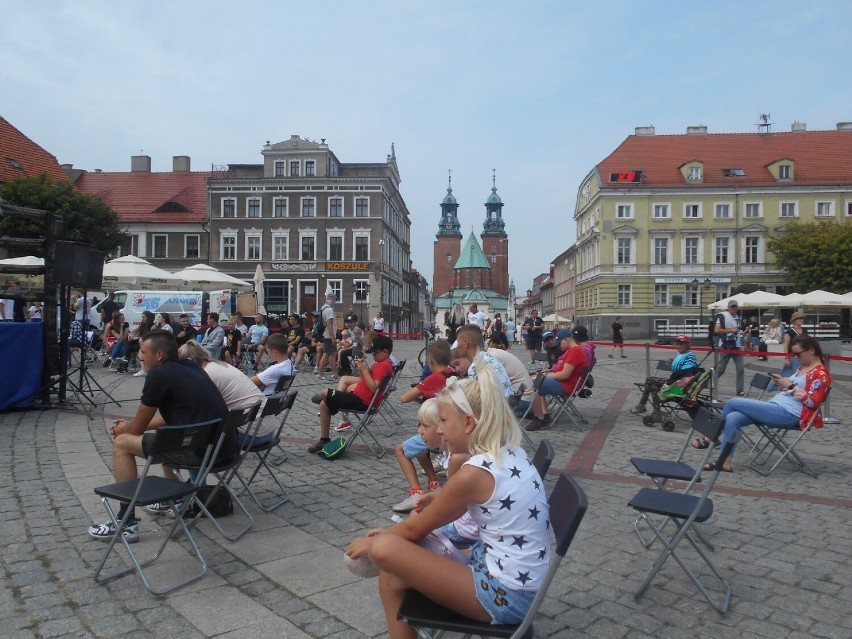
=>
[208,135,416,333]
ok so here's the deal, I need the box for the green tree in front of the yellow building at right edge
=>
[767,222,852,293]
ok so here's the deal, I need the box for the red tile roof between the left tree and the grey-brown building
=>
[76,171,210,223]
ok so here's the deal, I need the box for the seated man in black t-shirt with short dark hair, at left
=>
[89,331,230,542]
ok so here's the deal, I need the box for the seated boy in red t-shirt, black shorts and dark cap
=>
[308,335,393,454]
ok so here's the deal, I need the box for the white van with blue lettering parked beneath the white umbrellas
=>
[115,290,236,331]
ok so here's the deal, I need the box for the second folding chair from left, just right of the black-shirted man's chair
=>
[175,401,261,542]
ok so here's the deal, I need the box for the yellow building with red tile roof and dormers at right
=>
[574,123,852,338]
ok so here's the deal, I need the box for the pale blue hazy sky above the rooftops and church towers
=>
[0,0,852,293]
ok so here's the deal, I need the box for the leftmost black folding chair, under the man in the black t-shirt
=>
[94,419,222,596]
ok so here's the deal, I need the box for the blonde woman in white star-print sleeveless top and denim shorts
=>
[346,365,550,639]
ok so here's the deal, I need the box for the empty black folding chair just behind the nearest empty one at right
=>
[630,408,723,550]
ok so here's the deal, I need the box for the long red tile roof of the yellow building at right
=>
[598,130,852,189]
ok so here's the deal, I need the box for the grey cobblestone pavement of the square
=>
[0,342,852,639]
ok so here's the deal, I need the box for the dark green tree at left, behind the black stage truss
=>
[0,174,125,253]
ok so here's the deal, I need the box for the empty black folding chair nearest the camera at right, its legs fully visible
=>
[628,442,734,615]
